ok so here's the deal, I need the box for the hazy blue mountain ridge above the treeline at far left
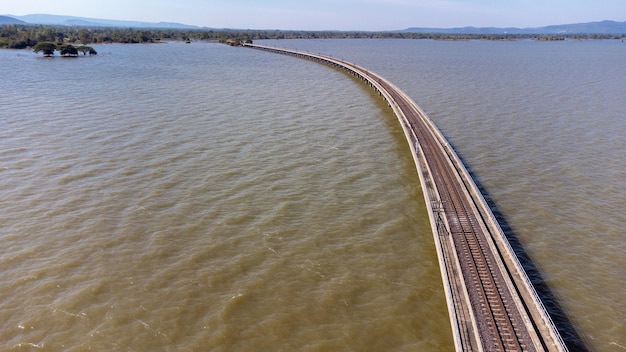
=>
[6,14,200,29]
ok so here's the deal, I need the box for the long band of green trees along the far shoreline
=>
[0,24,626,49]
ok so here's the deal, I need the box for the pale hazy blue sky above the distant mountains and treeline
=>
[0,0,626,30]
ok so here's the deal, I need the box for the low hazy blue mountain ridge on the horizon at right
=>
[402,21,626,34]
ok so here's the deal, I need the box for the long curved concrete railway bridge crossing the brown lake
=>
[244,44,567,351]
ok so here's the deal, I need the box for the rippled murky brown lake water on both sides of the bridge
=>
[0,40,626,351]
